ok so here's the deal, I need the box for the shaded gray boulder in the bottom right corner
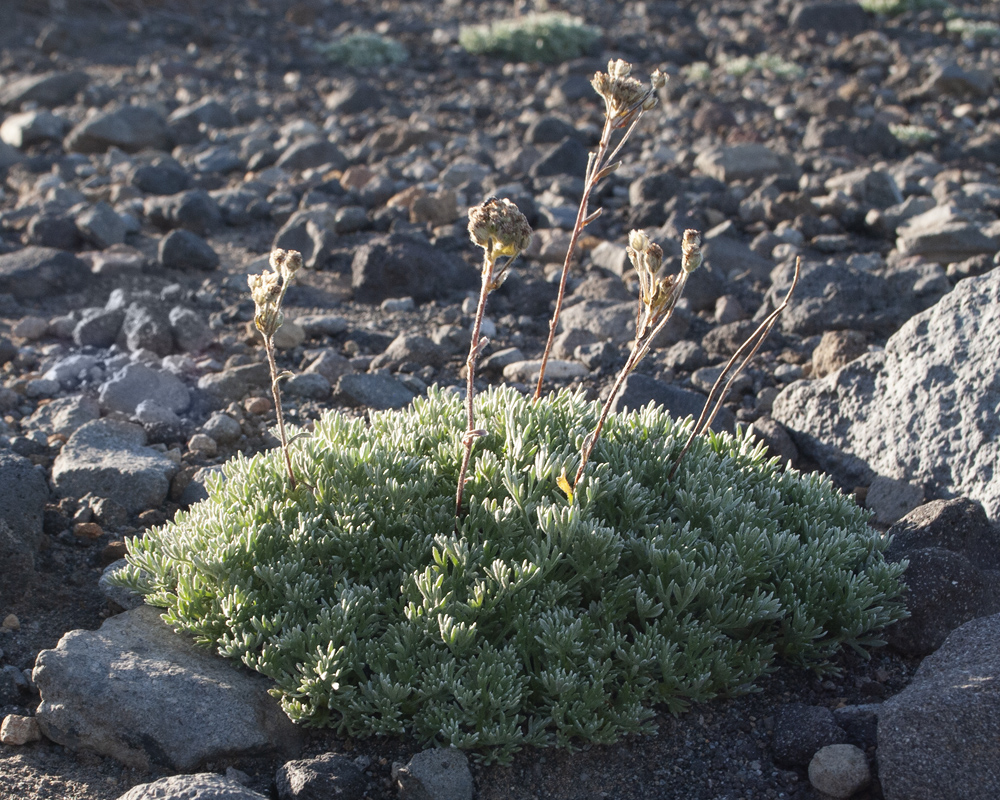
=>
[877,615,1000,800]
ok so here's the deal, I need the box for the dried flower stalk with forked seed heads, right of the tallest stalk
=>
[563,225,702,488]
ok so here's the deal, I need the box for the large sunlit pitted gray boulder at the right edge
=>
[772,270,1000,518]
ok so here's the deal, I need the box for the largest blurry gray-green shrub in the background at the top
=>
[458,12,601,64]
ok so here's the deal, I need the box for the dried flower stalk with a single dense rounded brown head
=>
[455,197,531,517]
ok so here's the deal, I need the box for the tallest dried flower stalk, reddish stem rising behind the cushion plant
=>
[534,59,667,400]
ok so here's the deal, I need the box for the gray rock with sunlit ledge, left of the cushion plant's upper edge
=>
[52,419,177,513]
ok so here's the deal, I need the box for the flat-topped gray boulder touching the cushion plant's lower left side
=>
[33,606,301,771]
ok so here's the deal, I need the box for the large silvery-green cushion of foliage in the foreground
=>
[113,389,905,759]
